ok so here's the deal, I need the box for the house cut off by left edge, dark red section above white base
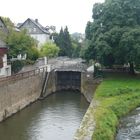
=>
[0,17,11,77]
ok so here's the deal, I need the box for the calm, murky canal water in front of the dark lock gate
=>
[0,91,89,140]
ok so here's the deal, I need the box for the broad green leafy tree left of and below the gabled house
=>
[7,30,38,60]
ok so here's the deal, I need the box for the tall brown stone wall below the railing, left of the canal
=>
[0,73,43,121]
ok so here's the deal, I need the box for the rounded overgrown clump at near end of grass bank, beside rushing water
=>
[92,108,118,140]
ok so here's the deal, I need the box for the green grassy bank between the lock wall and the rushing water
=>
[92,74,140,140]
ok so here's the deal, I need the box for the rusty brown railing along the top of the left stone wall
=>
[0,67,47,84]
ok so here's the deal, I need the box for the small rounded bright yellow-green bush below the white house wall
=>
[40,42,60,58]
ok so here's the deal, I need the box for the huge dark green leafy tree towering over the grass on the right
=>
[85,0,140,73]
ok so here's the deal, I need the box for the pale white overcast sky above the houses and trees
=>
[0,0,104,33]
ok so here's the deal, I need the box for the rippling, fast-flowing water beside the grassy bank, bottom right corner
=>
[116,108,140,140]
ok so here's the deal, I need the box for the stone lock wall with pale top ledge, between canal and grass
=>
[74,73,102,140]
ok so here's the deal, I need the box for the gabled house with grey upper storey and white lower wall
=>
[18,18,51,49]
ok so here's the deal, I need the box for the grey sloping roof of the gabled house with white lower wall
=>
[18,18,49,34]
